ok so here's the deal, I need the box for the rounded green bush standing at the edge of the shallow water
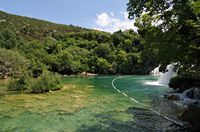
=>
[30,72,61,93]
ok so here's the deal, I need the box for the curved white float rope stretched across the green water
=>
[112,76,184,127]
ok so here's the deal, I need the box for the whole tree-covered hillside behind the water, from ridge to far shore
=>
[0,12,157,77]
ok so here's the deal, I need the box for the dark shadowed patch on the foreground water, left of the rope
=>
[78,107,189,132]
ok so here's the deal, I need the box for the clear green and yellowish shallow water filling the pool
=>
[0,76,185,132]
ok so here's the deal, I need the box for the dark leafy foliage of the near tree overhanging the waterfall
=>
[128,0,200,88]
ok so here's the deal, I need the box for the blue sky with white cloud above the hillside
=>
[0,0,136,33]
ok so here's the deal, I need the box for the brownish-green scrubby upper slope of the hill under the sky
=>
[0,11,93,39]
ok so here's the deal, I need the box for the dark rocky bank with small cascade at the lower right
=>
[165,87,200,131]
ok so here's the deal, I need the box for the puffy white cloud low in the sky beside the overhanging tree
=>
[94,12,137,33]
